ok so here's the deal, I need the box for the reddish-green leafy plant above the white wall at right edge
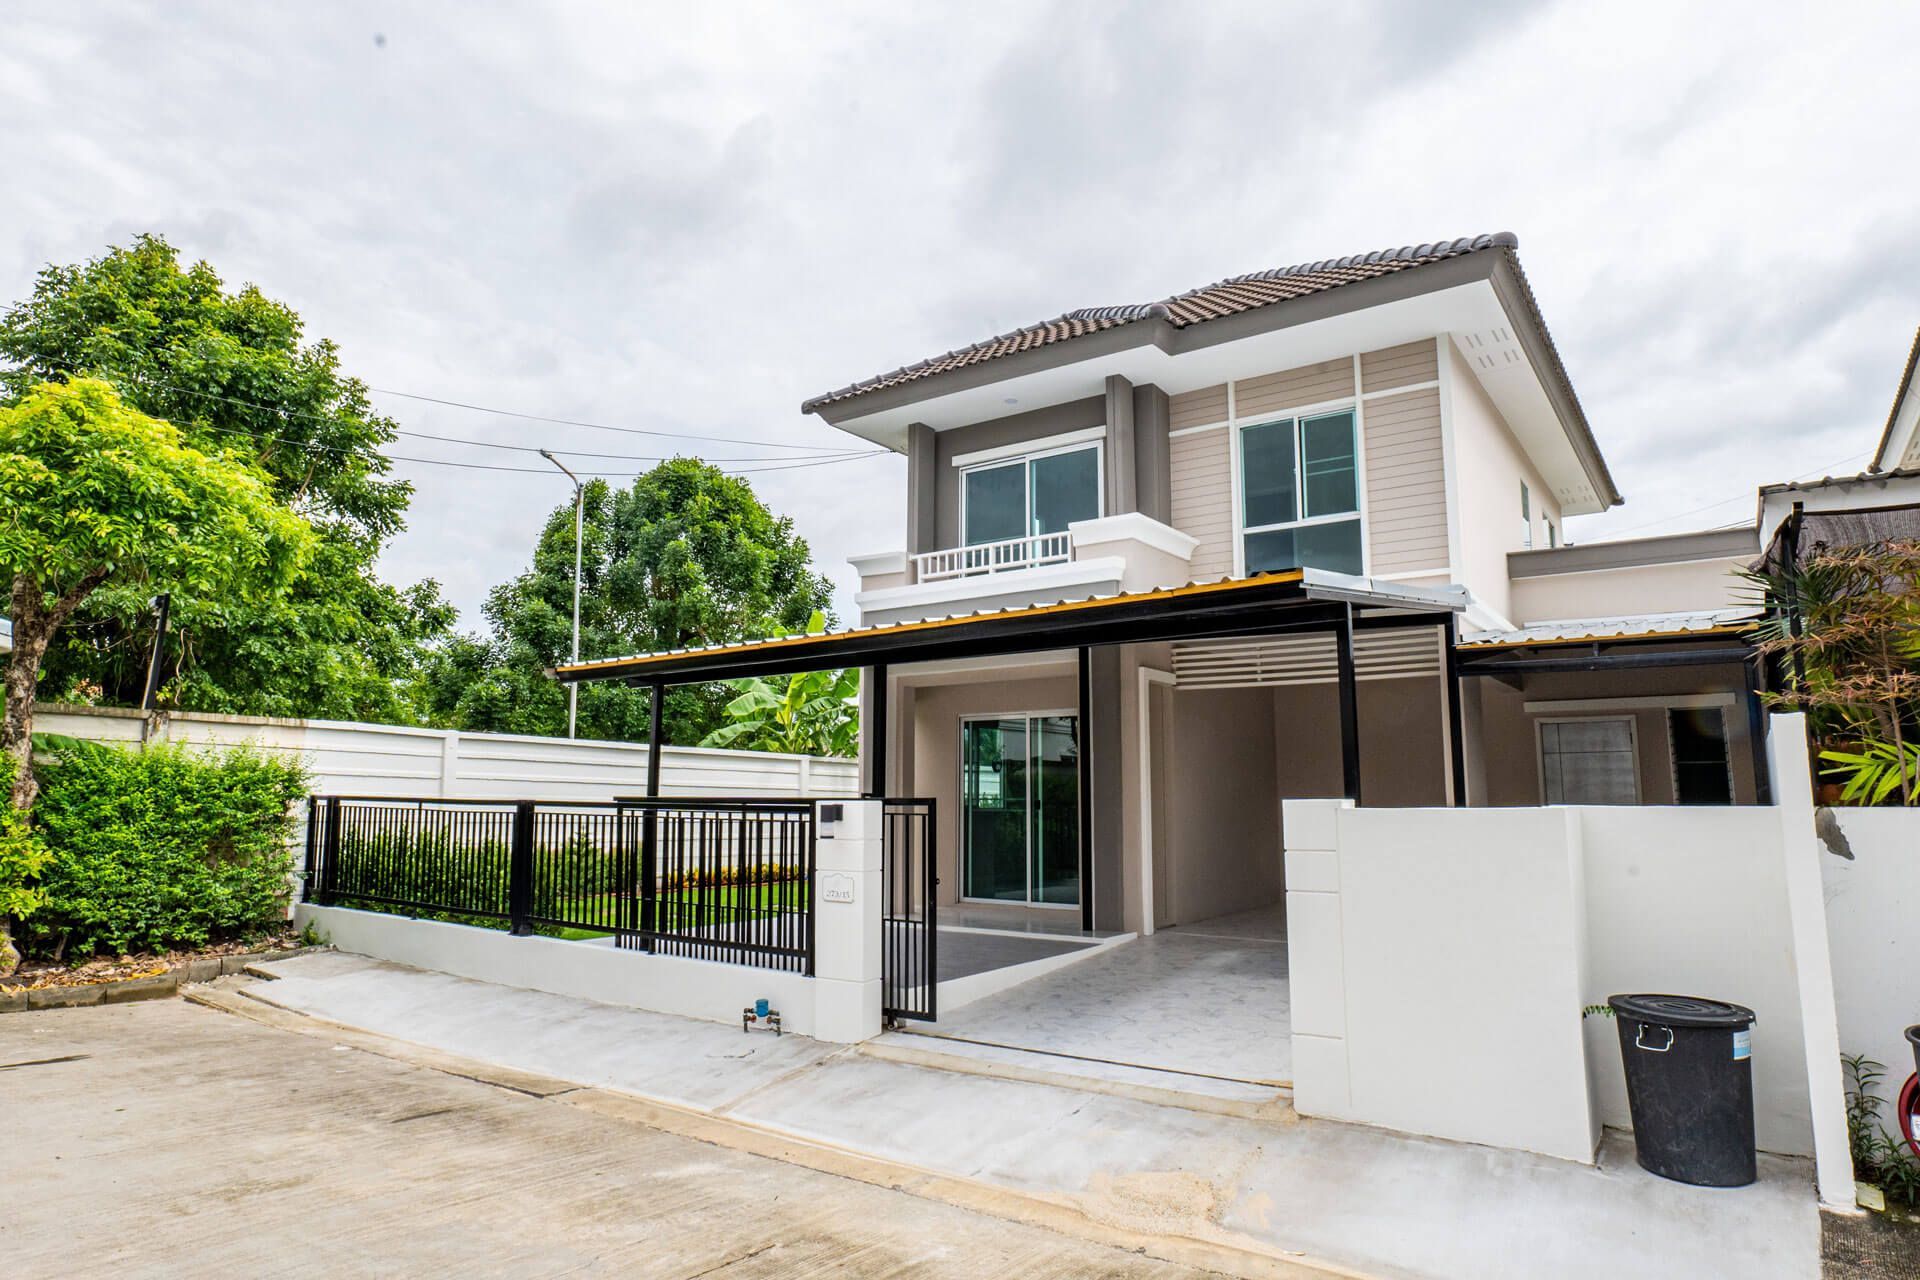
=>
[1747,539,1920,804]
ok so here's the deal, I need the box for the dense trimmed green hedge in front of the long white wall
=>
[27,739,307,956]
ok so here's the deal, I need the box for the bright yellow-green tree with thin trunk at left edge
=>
[0,378,313,973]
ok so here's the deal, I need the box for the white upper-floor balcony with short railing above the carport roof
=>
[851,512,1198,626]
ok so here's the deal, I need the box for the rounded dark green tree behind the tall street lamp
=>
[430,459,831,743]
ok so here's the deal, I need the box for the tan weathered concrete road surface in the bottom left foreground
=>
[0,1000,1228,1278]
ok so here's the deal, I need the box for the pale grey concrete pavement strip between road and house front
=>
[224,956,1818,1280]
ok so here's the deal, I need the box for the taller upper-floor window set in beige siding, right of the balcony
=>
[1240,409,1361,574]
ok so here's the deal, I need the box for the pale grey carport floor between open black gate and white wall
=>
[908,906,1292,1084]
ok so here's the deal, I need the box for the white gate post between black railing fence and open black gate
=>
[814,800,885,1044]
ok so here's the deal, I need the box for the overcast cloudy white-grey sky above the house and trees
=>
[0,0,1920,626]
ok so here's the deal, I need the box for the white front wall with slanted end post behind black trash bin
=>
[1284,716,1850,1203]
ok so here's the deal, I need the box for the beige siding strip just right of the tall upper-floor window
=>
[1361,385,1448,574]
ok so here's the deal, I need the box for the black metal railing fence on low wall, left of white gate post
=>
[305,796,814,973]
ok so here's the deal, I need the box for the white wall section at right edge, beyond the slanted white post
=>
[1820,808,1920,1130]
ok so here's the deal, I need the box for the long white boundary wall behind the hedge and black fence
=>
[33,702,860,800]
